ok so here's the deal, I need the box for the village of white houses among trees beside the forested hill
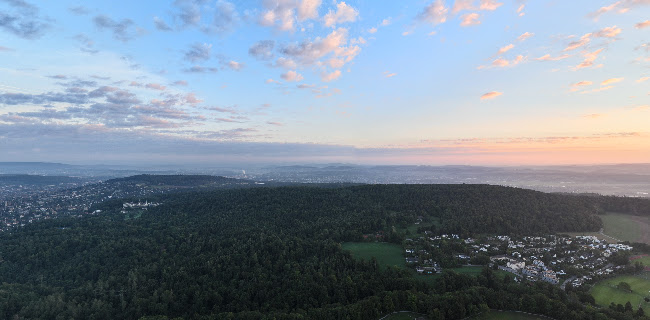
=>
[404,231,633,287]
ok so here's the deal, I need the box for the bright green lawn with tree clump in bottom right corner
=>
[590,273,650,309]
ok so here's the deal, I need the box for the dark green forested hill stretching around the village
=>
[0,185,636,319]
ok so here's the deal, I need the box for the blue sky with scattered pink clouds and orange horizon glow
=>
[0,0,650,165]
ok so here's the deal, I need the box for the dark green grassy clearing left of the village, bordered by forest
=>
[341,242,406,268]
